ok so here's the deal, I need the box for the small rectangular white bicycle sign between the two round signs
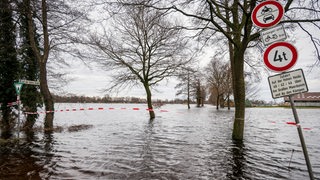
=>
[260,25,287,46]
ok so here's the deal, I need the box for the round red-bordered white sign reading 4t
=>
[263,42,298,72]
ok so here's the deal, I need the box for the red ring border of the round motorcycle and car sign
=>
[251,1,284,28]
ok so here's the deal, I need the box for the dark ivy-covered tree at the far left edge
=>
[0,0,19,131]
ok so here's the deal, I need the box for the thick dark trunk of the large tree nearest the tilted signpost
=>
[231,47,245,140]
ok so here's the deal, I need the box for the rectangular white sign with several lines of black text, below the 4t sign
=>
[268,69,308,99]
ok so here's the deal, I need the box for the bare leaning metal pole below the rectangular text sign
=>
[289,96,314,180]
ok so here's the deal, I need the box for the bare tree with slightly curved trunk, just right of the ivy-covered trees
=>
[23,0,84,131]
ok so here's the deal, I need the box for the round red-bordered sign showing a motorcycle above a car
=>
[251,1,284,28]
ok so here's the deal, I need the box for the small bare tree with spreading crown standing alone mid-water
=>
[80,0,192,119]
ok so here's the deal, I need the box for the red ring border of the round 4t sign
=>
[263,42,298,72]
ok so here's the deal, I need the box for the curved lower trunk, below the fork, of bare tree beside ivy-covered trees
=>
[40,62,54,131]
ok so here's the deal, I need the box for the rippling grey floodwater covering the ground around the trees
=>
[0,104,320,180]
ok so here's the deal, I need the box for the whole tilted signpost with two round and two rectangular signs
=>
[251,0,314,180]
